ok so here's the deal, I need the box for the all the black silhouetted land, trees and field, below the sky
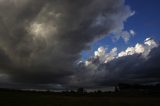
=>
[0,84,160,106]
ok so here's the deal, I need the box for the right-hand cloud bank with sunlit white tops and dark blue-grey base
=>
[75,38,160,87]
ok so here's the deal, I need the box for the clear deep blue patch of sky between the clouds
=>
[82,0,160,59]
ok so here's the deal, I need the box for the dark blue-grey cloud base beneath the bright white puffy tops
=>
[75,47,160,87]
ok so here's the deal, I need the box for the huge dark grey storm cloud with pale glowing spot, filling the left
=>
[0,0,132,89]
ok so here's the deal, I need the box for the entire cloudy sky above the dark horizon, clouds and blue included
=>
[0,0,160,90]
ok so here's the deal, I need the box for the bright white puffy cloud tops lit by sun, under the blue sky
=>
[82,38,159,66]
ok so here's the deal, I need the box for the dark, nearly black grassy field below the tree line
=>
[0,91,160,106]
